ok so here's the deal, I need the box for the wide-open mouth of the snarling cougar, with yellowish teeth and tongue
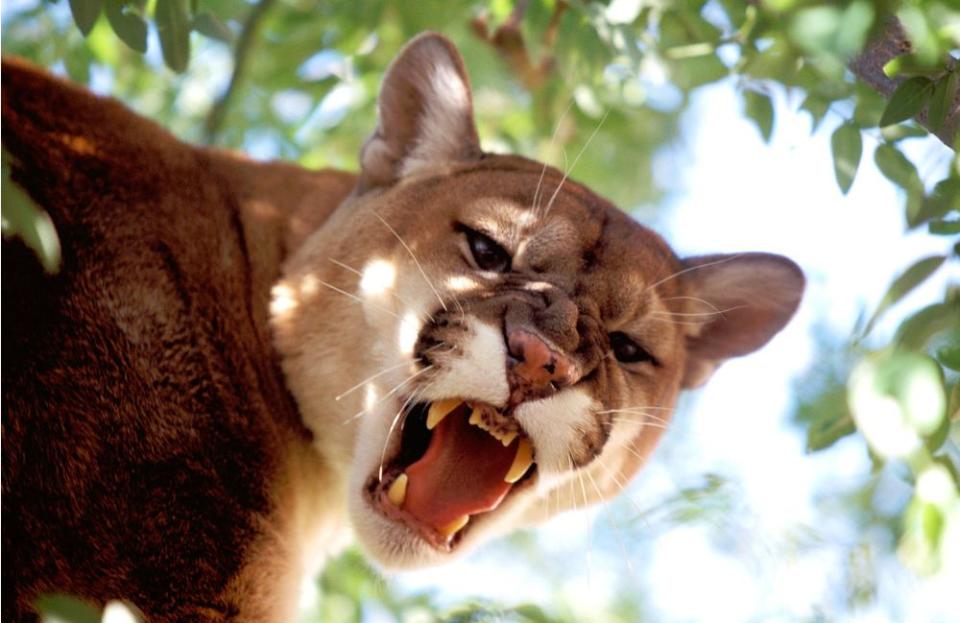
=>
[368,399,536,550]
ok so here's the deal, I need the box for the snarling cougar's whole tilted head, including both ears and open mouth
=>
[271,35,804,568]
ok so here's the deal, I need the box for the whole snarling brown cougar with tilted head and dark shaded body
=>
[2,34,804,621]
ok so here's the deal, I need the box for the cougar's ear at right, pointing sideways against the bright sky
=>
[683,253,805,387]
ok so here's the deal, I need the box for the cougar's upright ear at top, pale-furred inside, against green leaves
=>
[358,33,480,191]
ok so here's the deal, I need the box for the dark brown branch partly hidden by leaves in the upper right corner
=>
[850,17,960,149]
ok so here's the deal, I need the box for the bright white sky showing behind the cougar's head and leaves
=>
[378,83,960,622]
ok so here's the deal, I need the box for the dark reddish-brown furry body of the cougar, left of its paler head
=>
[2,61,353,621]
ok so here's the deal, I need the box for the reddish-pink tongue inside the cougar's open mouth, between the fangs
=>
[403,408,519,530]
